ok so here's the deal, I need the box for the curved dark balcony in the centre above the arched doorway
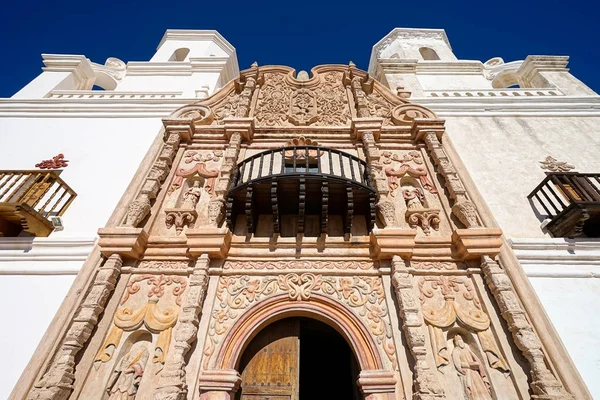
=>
[226,146,375,236]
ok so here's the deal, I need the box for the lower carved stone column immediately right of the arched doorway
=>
[392,256,446,400]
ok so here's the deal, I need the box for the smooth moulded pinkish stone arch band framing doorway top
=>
[215,293,385,371]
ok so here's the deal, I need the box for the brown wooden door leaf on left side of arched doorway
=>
[237,319,300,400]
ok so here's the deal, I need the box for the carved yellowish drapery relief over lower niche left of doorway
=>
[94,275,187,372]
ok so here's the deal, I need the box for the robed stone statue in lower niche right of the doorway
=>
[452,333,492,400]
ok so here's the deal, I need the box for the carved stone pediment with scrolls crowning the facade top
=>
[170,63,436,128]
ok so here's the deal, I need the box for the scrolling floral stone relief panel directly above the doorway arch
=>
[203,272,396,369]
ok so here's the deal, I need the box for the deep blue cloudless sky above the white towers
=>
[0,0,600,97]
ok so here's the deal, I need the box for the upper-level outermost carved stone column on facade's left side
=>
[123,132,181,228]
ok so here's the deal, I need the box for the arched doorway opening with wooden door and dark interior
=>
[236,318,363,400]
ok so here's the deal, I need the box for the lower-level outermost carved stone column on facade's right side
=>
[481,256,574,400]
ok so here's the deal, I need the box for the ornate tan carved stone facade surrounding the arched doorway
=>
[16,64,584,400]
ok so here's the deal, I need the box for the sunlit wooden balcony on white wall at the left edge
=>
[0,170,77,237]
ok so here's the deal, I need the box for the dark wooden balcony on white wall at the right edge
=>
[527,172,600,237]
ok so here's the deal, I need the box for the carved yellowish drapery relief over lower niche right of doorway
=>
[418,276,509,373]
